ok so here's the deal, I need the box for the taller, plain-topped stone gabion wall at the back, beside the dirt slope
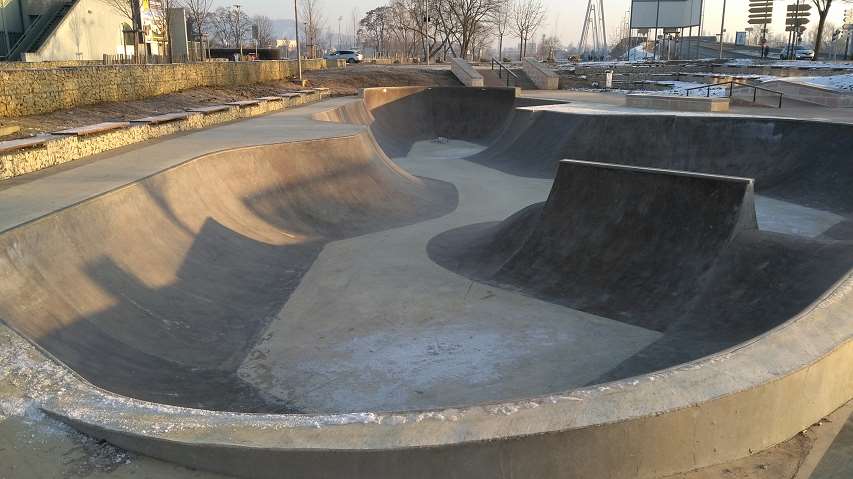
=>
[0,59,326,118]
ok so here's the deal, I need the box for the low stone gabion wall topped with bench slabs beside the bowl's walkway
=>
[0,89,329,180]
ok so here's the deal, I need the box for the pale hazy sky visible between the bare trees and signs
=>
[214,0,853,44]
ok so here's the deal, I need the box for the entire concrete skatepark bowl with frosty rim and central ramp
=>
[0,87,853,478]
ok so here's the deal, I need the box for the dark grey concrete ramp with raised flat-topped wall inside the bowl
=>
[429,160,853,381]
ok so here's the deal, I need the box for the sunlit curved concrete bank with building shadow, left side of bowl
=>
[0,133,456,412]
